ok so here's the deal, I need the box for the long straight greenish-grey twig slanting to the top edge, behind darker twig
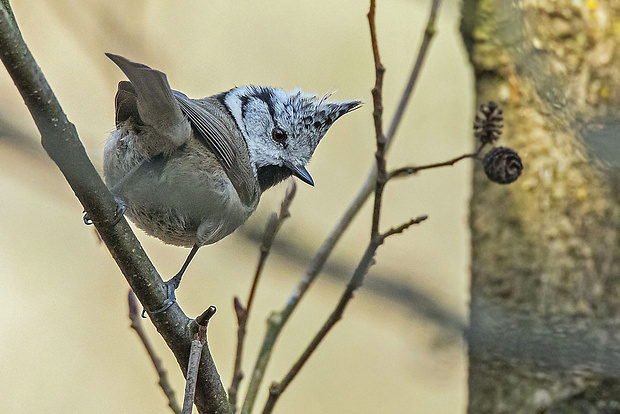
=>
[241,0,441,414]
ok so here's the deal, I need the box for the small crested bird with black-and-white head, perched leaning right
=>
[103,53,361,314]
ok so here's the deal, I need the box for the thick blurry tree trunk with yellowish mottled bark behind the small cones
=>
[461,0,620,414]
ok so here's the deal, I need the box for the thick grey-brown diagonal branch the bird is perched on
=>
[0,4,230,413]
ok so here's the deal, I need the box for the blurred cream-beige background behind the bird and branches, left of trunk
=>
[0,0,473,414]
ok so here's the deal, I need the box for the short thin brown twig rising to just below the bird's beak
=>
[228,181,297,413]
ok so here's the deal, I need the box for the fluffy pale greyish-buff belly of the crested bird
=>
[105,133,260,247]
